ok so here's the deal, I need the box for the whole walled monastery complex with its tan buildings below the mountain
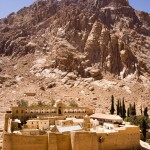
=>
[3,100,140,150]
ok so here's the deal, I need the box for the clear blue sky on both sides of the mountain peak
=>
[0,0,150,18]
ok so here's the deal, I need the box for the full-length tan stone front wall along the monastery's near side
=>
[3,127,140,150]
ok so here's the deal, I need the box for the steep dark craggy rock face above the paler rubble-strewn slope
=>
[0,0,150,78]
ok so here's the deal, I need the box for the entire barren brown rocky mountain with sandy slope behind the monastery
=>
[0,0,150,137]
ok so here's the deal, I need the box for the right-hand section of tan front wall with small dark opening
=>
[71,127,140,150]
